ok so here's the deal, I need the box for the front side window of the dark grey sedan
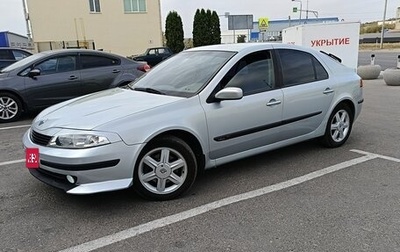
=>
[34,56,76,75]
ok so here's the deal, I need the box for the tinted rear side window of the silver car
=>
[278,49,328,87]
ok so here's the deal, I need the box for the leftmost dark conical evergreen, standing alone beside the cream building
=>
[165,11,185,53]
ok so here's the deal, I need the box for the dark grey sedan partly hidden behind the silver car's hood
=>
[0,49,150,123]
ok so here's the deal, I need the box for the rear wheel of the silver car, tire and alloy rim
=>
[321,104,353,148]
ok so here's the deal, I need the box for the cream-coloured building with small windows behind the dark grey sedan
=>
[26,0,162,56]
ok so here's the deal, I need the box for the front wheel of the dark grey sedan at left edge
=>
[0,92,22,123]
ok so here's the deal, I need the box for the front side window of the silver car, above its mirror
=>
[221,51,275,95]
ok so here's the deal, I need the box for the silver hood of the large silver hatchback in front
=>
[33,88,184,130]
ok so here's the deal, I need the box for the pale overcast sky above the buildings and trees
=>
[0,0,400,37]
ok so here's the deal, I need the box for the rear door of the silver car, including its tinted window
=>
[277,49,335,139]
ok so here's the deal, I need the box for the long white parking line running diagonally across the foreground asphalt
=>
[60,153,381,252]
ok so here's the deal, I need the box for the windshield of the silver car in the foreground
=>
[130,51,235,97]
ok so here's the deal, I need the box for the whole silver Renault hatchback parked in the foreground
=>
[23,43,363,200]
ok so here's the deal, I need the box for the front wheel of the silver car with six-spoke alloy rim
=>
[133,136,197,200]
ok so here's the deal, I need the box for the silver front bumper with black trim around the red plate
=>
[23,129,142,194]
